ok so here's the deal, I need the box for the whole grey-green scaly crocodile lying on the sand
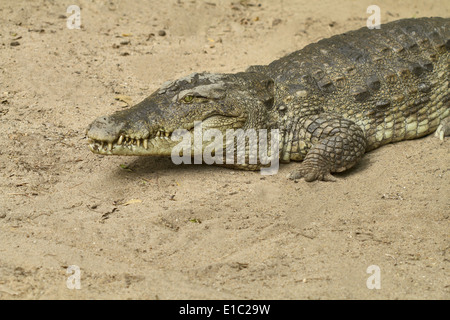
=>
[86,17,450,181]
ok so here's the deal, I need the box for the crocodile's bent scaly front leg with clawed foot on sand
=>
[289,113,366,181]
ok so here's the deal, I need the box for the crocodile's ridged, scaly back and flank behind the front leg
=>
[266,18,450,150]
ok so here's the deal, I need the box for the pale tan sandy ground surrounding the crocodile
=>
[0,0,450,299]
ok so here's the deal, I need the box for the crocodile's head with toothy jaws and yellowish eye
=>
[86,72,274,162]
